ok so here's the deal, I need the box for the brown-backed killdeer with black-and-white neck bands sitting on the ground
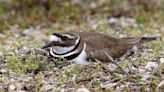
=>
[43,32,157,64]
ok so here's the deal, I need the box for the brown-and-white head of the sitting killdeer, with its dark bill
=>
[43,32,80,54]
